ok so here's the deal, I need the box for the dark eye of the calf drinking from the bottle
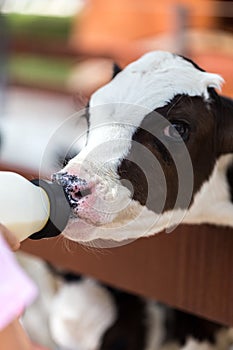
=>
[163,121,190,141]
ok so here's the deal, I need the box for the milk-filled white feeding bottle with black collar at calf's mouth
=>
[0,171,70,241]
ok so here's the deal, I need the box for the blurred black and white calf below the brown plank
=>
[17,252,233,350]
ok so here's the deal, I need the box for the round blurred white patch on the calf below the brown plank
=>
[50,278,116,350]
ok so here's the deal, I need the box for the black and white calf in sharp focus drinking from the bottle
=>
[53,51,233,242]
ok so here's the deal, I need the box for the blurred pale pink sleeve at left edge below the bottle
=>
[0,235,37,330]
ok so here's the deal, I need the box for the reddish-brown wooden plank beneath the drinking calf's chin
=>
[22,225,233,326]
